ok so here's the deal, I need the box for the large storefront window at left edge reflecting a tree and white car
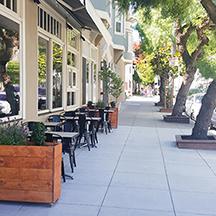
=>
[0,15,20,118]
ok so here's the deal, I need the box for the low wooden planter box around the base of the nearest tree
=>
[176,135,216,150]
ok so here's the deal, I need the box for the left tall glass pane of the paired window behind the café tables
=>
[38,37,48,110]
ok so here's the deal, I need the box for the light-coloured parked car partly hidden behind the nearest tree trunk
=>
[185,93,216,128]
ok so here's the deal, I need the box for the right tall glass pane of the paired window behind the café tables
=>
[53,43,63,108]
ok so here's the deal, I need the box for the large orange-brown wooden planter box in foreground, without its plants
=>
[0,144,62,203]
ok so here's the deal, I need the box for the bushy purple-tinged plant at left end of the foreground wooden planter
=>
[0,121,27,145]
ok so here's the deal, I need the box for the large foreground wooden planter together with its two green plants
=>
[0,122,62,203]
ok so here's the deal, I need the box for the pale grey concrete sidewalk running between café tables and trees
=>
[0,97,216,216]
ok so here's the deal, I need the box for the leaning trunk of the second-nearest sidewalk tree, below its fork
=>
[172,66,197,116]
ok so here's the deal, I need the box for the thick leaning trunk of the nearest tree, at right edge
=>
[191,79,216,139]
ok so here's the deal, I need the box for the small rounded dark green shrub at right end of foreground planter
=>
[31,122,46,146]
